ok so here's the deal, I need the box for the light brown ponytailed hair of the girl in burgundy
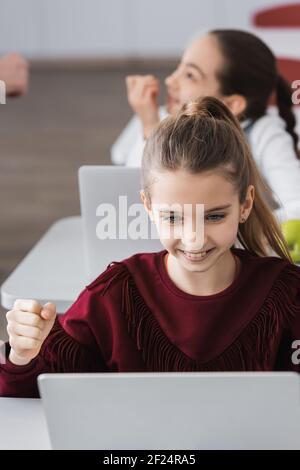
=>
[142,97,291,261]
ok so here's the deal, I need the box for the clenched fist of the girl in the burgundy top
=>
[6,299,56,366]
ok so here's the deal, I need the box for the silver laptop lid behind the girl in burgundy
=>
[79,166,163,280]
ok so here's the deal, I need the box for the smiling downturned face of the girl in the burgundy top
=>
[142,170,254,272]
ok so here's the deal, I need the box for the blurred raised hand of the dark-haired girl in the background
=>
[126,75,160,138]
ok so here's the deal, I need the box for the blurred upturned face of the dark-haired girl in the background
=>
[165,34,224,114]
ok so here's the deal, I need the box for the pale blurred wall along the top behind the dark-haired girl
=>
[0,0,293,59]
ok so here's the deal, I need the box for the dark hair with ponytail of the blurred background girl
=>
[209,29,299,156]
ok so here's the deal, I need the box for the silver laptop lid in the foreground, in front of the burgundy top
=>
[38,372,300,450]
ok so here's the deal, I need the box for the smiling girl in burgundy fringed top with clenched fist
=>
[0,98,300,397]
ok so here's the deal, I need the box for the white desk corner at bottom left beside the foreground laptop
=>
[0,398,51,450]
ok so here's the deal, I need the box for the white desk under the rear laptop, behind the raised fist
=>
[1,216,88,313]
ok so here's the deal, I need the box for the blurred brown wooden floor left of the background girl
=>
[0,63,172,339]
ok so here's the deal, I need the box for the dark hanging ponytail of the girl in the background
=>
[276,75,300,154]
